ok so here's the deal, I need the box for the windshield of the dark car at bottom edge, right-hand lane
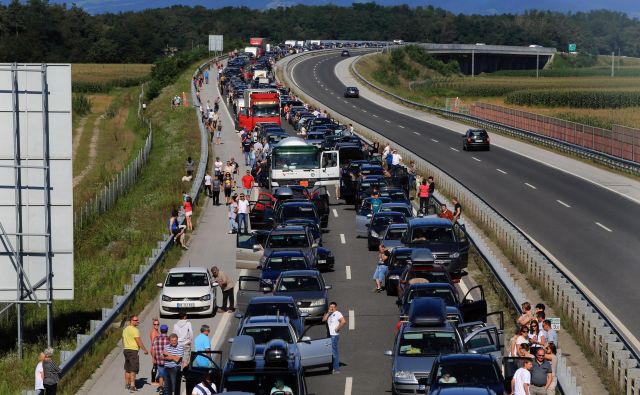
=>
[435,361,502,386]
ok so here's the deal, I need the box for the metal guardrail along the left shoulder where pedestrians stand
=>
[22,57,223,395]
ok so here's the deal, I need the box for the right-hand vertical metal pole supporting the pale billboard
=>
[42,64,53,347]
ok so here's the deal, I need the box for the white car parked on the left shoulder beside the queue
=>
[157,267,218,316]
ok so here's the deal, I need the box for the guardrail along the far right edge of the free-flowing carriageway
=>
[351,53,640,175]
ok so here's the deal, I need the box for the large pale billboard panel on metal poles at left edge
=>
[0,64,74,301]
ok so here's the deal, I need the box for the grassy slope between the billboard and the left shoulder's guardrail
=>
[0,59,205,394]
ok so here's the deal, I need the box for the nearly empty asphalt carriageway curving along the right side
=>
[293,54,640,340]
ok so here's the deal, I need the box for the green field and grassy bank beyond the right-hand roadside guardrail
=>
[357,47,640,128]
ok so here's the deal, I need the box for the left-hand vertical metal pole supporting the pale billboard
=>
[11,63,23,359]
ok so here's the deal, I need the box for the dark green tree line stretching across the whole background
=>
[0,0,640,63]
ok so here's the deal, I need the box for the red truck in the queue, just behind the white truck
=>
[238,89,280,130]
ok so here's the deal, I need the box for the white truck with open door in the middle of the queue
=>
[269,137,340,188]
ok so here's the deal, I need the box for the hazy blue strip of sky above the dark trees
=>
[5,0,640,19]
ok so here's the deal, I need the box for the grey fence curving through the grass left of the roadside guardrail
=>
[73,84,153,229]
